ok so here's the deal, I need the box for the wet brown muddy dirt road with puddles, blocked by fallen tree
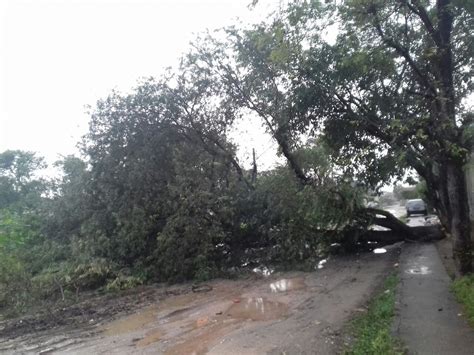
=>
[0,247,399,354]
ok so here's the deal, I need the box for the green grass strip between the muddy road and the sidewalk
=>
[344,274,404,355]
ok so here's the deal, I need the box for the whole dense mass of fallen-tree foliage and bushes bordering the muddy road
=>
[0,76,374,318]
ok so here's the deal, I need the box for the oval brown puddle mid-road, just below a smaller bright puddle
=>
[226,297,288,321]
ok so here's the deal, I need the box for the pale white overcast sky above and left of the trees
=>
[0,0,279,171]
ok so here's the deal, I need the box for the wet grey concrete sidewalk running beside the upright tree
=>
[395,244,474,355]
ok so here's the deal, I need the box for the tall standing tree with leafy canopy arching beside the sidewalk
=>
[191,0,474,273]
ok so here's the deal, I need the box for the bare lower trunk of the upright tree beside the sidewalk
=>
[446,162,473,275]
